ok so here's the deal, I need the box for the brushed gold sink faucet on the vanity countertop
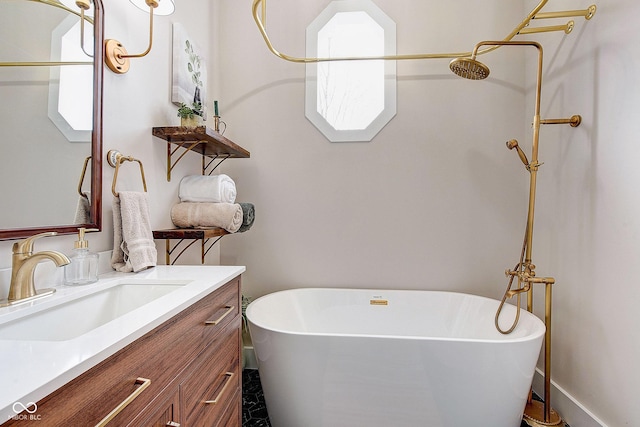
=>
[0,231,70,306]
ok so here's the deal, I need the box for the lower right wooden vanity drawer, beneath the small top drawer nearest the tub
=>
[180,316,241,427]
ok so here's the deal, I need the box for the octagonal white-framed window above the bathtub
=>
[305,0,396,142]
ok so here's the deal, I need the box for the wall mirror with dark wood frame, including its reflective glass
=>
[0,0,104,240]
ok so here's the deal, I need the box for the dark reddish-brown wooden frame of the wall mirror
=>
[0,0,104,240]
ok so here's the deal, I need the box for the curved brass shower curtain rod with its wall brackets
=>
[251,0,596,64]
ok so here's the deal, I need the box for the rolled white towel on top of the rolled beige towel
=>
[178,174,236,203]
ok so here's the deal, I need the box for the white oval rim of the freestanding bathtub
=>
[246,288,546,345]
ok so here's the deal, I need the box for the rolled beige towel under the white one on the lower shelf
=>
[171,203,242,233]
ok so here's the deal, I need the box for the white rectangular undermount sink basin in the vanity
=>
[0,283,184,341]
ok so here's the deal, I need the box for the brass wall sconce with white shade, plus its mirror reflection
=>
[62,0,175,74]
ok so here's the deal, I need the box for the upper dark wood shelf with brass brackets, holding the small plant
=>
[152,126,251,181]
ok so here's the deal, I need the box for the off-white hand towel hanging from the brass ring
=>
[111,191,158,273]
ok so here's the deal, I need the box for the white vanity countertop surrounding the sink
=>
[0,266,245,424]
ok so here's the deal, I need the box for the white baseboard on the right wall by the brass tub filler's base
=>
[533,369,608,427]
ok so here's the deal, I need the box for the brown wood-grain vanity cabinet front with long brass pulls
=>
[3,277,242,427]
